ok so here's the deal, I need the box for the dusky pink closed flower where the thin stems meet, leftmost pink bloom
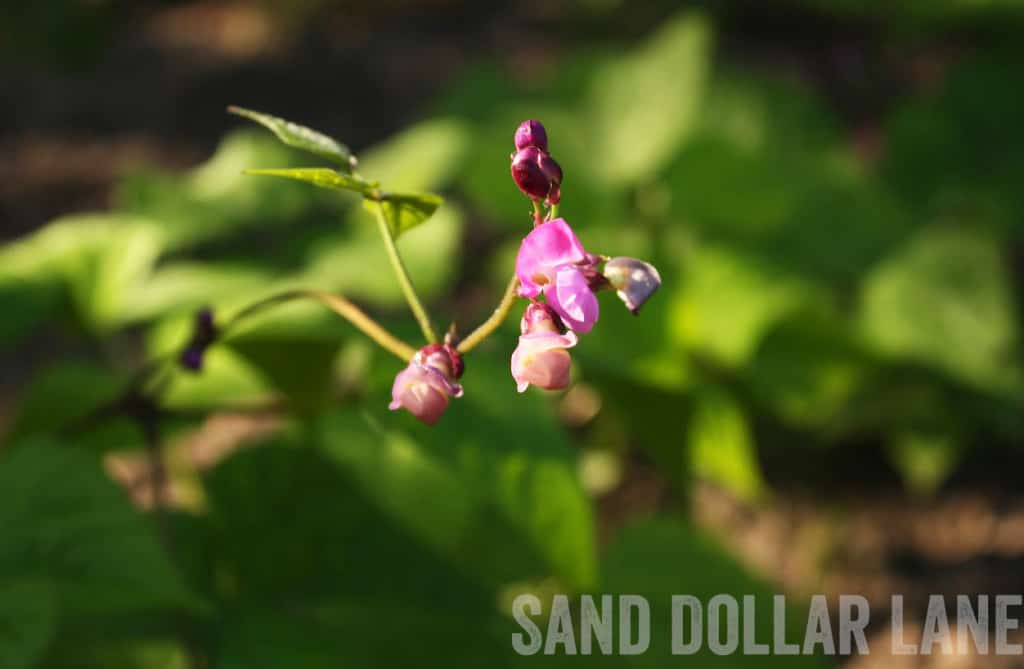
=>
[388,344,462,425]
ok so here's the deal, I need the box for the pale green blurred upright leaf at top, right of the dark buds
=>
[588,13,712,185]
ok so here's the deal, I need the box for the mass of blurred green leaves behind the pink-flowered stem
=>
[0,0,1024,669]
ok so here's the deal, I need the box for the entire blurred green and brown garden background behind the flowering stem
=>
[0,0,1024,669]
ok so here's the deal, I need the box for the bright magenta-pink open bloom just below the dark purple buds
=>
[515,218,598,333]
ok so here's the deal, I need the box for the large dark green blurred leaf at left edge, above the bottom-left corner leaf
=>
[0,440,201,625]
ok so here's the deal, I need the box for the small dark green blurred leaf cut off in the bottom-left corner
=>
[0,578,57,669]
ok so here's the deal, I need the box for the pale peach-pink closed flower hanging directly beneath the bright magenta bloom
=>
[512,302,579,392]
